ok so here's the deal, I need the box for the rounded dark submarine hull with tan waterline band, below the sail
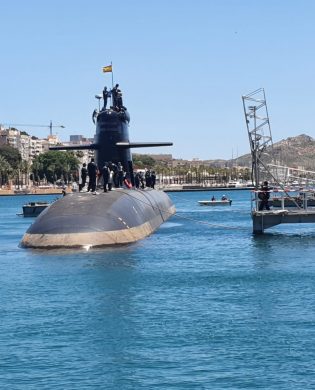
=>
[21,188,175,249]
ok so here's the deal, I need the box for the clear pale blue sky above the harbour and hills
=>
[0,0,315,159]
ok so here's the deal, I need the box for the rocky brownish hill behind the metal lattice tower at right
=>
[229,134,315,171]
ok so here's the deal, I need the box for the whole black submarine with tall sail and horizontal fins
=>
[20,84,176,249]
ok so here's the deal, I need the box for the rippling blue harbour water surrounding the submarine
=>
[0,191,315,390]
